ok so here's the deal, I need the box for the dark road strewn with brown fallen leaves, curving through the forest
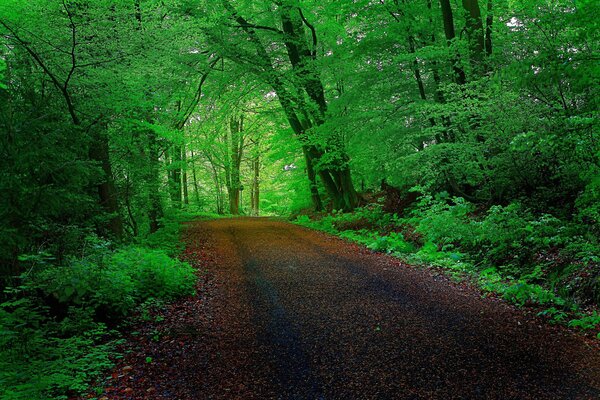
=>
[94,218,600,400]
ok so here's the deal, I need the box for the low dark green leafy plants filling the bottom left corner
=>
[0,297,116,400]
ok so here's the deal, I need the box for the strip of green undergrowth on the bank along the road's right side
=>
[296,196,600,338]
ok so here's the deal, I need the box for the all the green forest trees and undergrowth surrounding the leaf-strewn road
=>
[0,0,600,399]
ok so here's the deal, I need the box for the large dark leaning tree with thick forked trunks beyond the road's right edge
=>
[205,0,358,210]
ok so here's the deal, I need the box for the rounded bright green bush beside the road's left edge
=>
[32,247,196,318]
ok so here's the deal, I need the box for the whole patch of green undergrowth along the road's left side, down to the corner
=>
[0,211,206,400]
